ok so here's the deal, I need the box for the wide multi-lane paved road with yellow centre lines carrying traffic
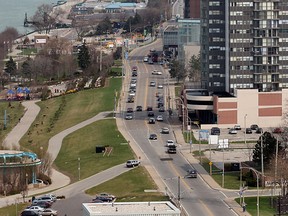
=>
[123,40,235,215]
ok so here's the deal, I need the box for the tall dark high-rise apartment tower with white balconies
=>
[201,0,288,95]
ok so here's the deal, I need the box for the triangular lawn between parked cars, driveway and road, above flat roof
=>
[86,166,169,202]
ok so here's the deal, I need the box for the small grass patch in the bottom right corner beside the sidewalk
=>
[235,197,278,216]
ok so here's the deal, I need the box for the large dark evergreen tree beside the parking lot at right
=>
[253,131,282,165]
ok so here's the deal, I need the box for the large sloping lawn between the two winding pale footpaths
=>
[20,78,121,154]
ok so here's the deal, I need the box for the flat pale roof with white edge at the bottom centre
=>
[82,201,180,216]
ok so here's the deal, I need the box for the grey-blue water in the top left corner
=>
[0,0,57,34]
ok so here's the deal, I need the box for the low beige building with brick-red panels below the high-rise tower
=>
[179,89,288,129]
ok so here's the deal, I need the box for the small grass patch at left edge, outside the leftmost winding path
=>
[0,101,24,143]
